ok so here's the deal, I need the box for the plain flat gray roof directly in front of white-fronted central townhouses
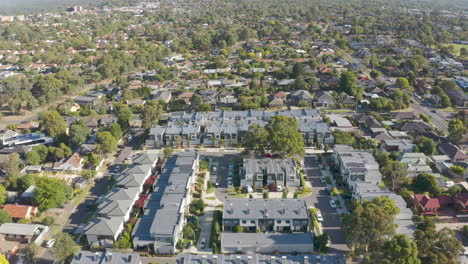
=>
[221,232,314,248]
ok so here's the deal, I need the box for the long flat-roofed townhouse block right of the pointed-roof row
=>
[132,152,199,254]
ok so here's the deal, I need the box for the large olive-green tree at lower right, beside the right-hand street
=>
[343,197,399,258]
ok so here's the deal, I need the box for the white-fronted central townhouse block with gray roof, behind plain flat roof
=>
[222,199,309,233]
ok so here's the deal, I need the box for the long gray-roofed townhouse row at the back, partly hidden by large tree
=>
[146,109,334,148]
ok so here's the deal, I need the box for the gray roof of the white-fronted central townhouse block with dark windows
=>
[223,199,309,219]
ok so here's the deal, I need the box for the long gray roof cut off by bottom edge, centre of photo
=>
[176,254,346,264]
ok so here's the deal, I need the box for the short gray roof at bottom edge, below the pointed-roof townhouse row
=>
[70,251,140,264]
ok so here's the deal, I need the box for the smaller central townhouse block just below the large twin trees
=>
[239,158,300,189]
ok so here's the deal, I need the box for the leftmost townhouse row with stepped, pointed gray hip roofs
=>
[83,153,158,247]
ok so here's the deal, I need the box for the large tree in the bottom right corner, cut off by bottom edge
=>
[414,218,463,264]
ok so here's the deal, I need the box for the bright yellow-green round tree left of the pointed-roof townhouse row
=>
[34,177,72,211]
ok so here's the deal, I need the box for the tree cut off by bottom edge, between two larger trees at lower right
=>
[372,235,421,264]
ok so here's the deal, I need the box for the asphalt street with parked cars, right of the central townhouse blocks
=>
[304,156,349,253]
